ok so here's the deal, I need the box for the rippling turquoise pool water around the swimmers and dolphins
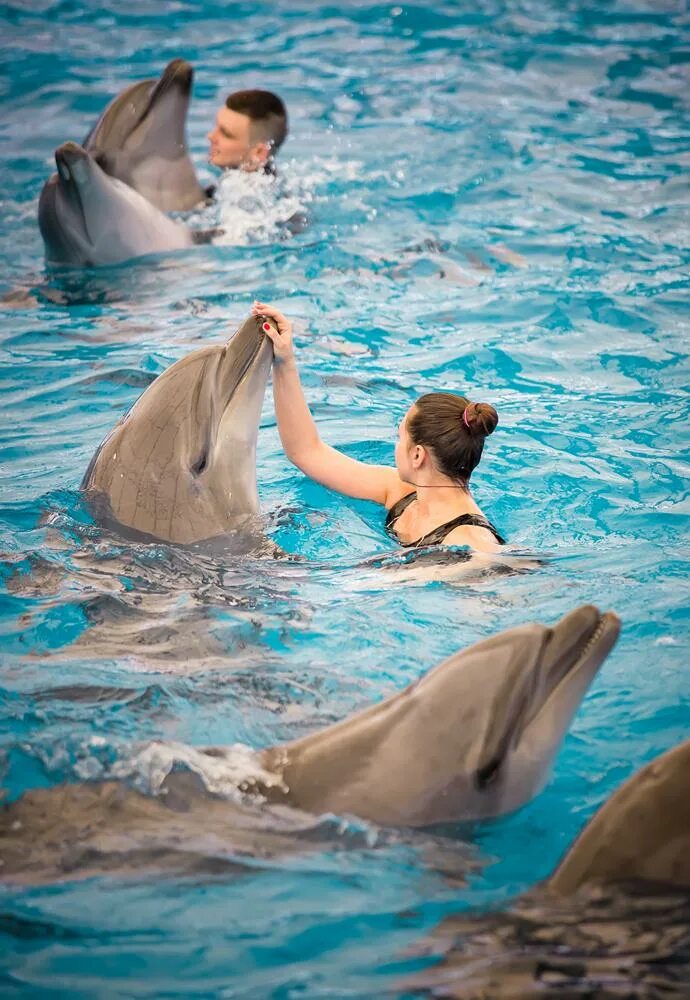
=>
[0,0,690,998]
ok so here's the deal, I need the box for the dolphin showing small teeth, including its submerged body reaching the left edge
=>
[0,607,619,881]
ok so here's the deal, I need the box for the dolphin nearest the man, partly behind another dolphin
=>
[84,59,206,212]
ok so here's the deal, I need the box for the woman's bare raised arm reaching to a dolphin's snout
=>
[252,302,402,506]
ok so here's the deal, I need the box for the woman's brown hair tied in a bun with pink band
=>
[407,392,498,485]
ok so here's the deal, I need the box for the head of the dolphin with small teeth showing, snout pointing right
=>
[390,605,620,825]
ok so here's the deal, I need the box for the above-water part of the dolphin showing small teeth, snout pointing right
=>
[263,605,620,826]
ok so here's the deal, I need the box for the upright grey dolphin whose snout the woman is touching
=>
[81,316,273,544]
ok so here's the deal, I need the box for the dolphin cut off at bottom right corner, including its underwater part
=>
[399,740,690,1000]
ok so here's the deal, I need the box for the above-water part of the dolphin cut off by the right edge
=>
[548,740,690,895]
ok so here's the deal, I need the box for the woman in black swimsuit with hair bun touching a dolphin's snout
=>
[252,302,504,552]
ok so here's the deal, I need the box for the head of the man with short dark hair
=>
[208,90,287,171]
